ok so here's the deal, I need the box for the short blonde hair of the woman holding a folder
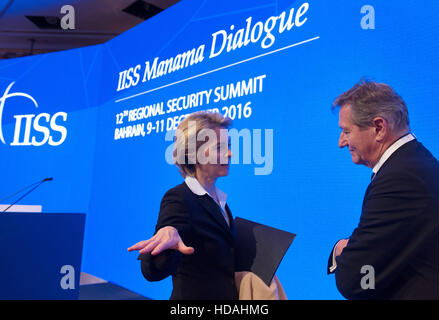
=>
[173,111,232,176]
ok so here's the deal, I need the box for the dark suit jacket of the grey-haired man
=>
[330,140,439,299]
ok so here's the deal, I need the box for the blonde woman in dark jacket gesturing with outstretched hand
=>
[128,112,238,300]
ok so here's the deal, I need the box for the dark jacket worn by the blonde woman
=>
[139,183,238,300]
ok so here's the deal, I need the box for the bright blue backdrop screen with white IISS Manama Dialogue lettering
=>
[0,0,439,299]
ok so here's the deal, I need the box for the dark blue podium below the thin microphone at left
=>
[0,212,85,300]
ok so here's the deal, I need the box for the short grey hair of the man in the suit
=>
[332,79,409,132]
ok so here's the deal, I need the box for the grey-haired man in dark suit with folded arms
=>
[328,81,439,299]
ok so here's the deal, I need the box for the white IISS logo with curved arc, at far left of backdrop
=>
[0,82,67,147]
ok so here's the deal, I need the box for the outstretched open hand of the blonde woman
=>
[128,226,194,256]
